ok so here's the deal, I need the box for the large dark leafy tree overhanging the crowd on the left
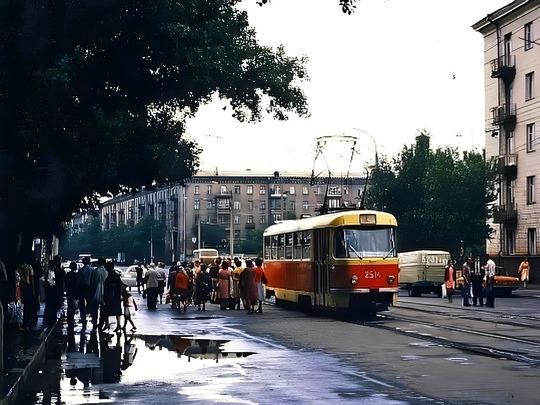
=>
[0,0,307,268]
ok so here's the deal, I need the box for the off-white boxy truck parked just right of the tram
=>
[398,250,451,297]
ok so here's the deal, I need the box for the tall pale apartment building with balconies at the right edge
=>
[472,0,540,274]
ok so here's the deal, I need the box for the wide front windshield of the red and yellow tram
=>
[334,228,397,259]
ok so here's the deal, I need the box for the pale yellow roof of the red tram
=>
[264,210,397,235]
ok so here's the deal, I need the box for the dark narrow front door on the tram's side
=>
[313,229,330,306]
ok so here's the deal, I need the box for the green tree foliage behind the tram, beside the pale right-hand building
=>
[366,133,496,256]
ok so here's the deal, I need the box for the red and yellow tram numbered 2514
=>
[263,210,399,313]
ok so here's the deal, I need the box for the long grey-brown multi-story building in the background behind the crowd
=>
[101,172,365,261]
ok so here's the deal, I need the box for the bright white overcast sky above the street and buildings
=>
[187,0,511,175]
